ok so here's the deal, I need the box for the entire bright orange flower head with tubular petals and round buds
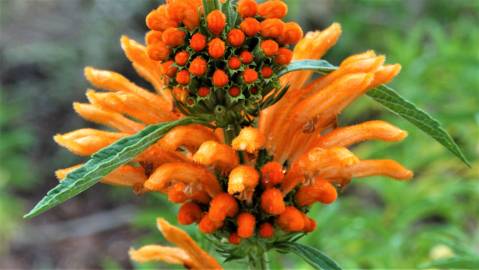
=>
[54,0,412,269]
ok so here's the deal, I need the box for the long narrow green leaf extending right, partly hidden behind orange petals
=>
[280,60,471,167]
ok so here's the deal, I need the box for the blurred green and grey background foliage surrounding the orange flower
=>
[0,0,479,269]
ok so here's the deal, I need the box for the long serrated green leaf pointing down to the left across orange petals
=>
[24,117,206,218]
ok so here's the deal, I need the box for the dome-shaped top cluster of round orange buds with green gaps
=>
[145,0,303,120]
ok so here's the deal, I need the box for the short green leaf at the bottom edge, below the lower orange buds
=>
[276,242,341,270]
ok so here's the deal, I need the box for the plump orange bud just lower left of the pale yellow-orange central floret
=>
[208,193,238,222]
